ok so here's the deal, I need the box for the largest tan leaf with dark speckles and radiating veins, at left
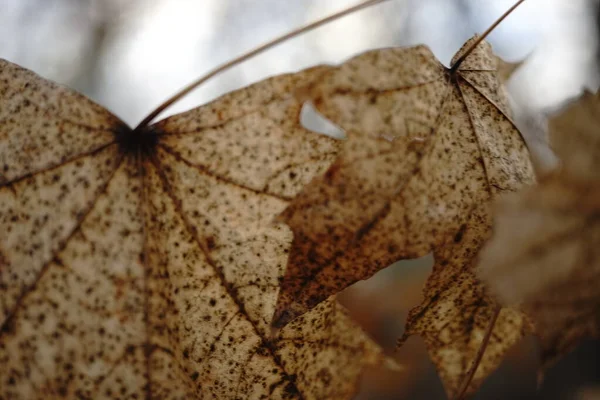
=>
[0,60,382,400]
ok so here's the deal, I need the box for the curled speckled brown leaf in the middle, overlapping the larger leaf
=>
[274,38,534,396]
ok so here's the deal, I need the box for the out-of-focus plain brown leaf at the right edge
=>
[480,93,600,367]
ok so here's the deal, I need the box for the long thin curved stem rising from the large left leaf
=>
[135,0,387,130]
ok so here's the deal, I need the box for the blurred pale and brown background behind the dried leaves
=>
[0,0,600,400]
